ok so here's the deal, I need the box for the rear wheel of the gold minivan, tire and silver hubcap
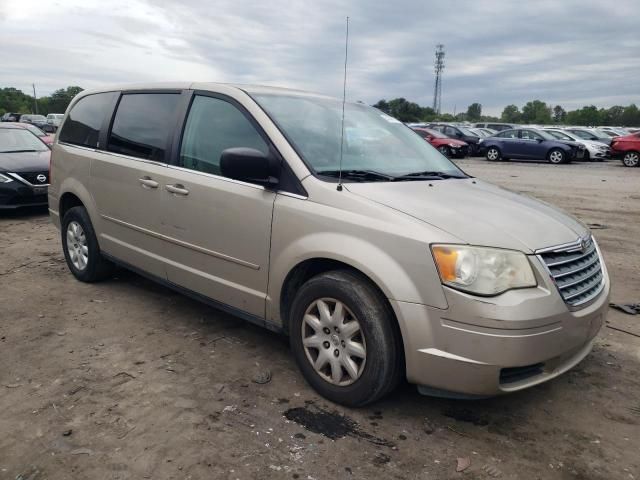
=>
[60,207,115,283]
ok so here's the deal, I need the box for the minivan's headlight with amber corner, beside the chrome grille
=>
[431,245,537,295]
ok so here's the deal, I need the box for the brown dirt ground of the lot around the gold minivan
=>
[0,159,640,480]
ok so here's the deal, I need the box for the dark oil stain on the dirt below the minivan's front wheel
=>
[284,405,395,447]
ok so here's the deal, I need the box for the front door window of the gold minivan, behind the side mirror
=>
[180,96,269,175]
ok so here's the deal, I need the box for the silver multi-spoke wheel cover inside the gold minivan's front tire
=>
[302,298,367,387]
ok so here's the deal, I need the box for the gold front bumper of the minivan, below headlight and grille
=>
[391,255,610,398]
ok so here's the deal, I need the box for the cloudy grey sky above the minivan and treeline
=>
[0,0,640,114]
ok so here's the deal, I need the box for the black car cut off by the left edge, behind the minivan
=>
[0,123,51,209]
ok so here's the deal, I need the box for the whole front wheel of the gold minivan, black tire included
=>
[289,270,404,407]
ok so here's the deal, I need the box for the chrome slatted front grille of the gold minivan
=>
[539,238,604,307]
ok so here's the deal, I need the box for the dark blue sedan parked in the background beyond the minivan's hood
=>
[481,128,584,163]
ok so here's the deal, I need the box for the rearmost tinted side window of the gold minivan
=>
[60,92,117,148]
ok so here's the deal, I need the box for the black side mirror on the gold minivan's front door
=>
[220,148,280,186]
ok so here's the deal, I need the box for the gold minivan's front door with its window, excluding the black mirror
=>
[162,95,276,318]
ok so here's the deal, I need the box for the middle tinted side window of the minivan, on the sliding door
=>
[107,93,180,162]
